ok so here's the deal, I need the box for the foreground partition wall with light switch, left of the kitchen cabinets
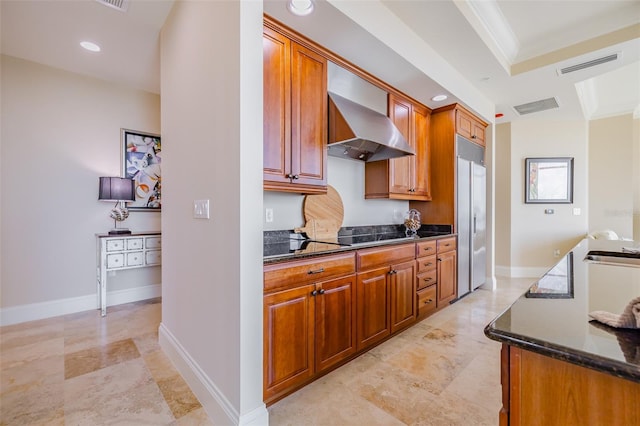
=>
[159,1,268,424]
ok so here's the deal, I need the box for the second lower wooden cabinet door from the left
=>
[315,275,356,371]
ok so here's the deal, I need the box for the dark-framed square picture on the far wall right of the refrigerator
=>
[524,157,573,204]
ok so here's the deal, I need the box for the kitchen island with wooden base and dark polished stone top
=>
[485,239,640,425]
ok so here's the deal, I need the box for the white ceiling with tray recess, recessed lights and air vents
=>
[0,0,640,123]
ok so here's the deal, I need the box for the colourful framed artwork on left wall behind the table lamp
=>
[121,129,162,211]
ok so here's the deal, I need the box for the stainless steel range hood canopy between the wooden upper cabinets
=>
[328,92,415,161]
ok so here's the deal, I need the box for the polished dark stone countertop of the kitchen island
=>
[484,239,640,383]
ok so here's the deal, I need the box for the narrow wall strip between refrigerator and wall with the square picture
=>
[495,123,512,275]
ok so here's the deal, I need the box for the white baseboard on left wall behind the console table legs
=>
[0,284,162,326]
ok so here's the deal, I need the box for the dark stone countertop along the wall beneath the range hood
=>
[263,225,455,264]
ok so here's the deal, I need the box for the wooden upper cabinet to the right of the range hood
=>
[365,94,431,201]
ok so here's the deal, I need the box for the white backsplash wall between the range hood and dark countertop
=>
[262,156,409,230]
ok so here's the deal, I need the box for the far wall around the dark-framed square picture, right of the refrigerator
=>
[510,119,588,277]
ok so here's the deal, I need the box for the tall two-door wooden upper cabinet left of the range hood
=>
[263,27,327,194]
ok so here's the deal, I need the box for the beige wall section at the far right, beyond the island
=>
[589,114,640,238]
